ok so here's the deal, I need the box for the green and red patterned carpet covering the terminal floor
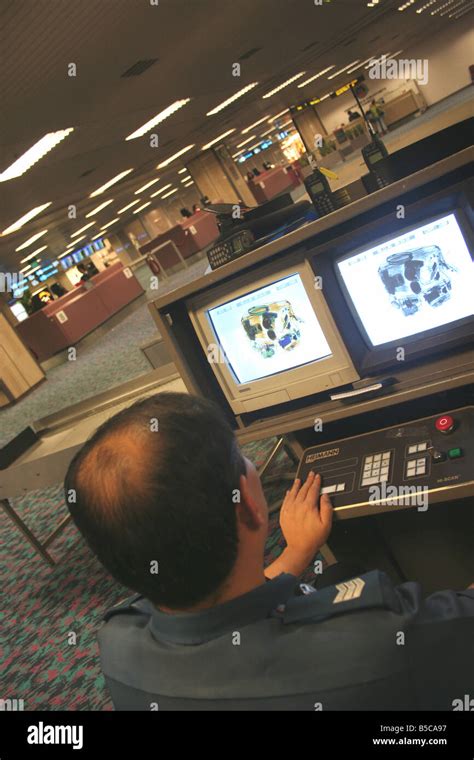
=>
[0,296,314,710]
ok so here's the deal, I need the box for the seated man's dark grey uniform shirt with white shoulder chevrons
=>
[99,571,474,710]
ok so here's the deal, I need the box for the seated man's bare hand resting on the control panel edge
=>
[265,472,332,578]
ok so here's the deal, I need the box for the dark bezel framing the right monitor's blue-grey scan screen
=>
[333,206,474,354]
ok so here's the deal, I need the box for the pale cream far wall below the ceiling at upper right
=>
[316,17,474,132]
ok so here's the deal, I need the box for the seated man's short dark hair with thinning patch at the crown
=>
[65,393,245,609]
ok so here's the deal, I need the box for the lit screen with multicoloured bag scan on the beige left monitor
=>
[208,274,331,383]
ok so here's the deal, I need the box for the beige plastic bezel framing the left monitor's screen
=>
[186,256,360,411]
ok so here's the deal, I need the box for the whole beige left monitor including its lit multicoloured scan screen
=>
[188,261,359,414]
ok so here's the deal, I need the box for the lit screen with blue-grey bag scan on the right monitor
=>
[337,214,474,346]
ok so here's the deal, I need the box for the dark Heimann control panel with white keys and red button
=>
[297,406,474,518]
